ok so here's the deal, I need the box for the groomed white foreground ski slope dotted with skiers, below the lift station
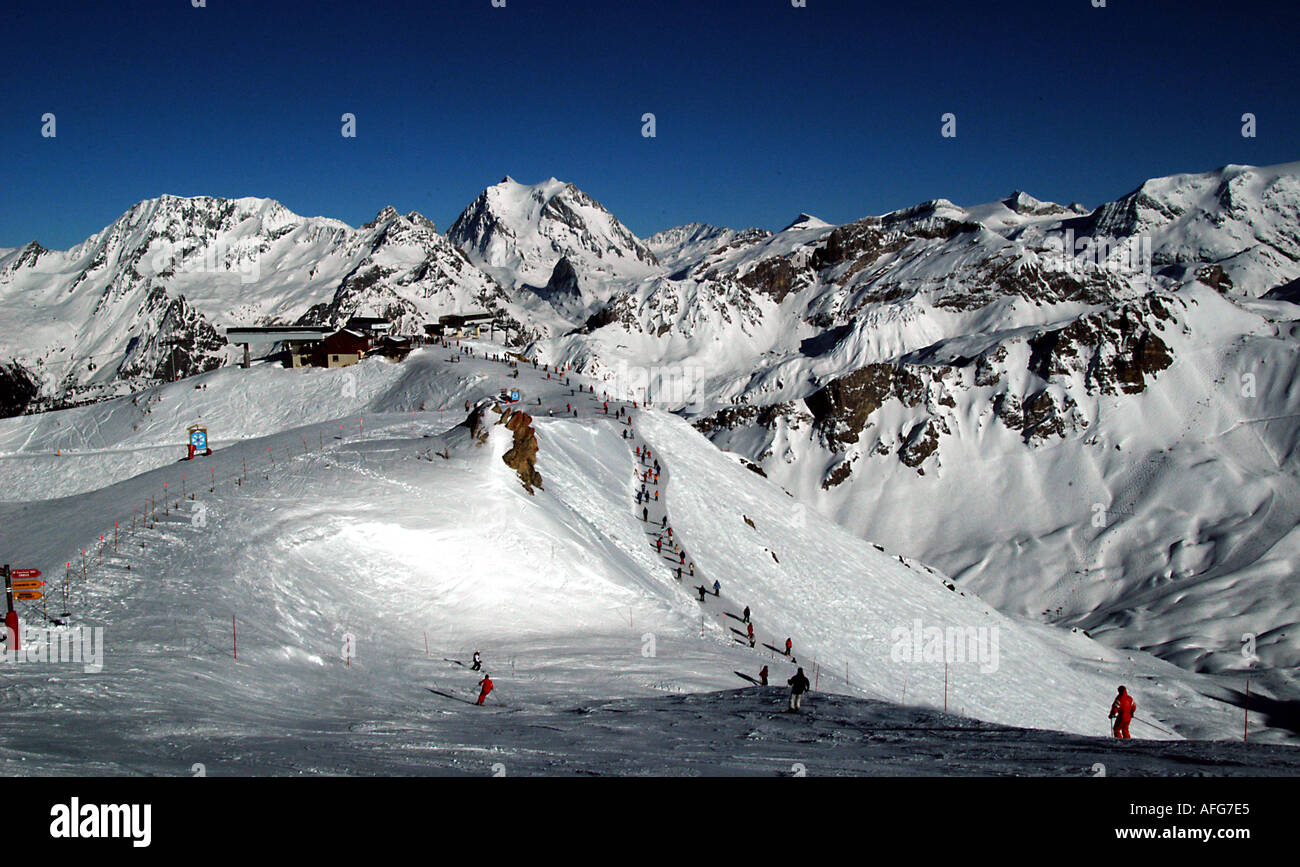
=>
[0,344,1294,775]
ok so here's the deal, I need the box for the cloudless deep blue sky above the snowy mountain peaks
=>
[0,0,1300,248]
